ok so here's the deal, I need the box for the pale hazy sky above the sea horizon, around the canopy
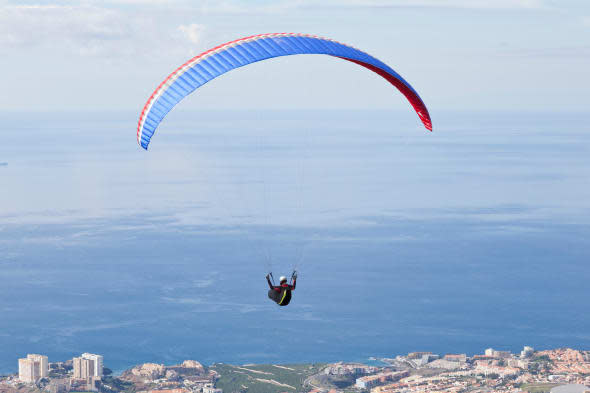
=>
[0,0,590,113]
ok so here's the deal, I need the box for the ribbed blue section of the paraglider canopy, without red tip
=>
[139,35,421,150]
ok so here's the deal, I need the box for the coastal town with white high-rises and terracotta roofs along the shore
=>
[0,346,590,393]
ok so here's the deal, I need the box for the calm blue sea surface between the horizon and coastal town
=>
[0,111,590,373]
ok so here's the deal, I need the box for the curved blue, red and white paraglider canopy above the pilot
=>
[137,33,432,150]
